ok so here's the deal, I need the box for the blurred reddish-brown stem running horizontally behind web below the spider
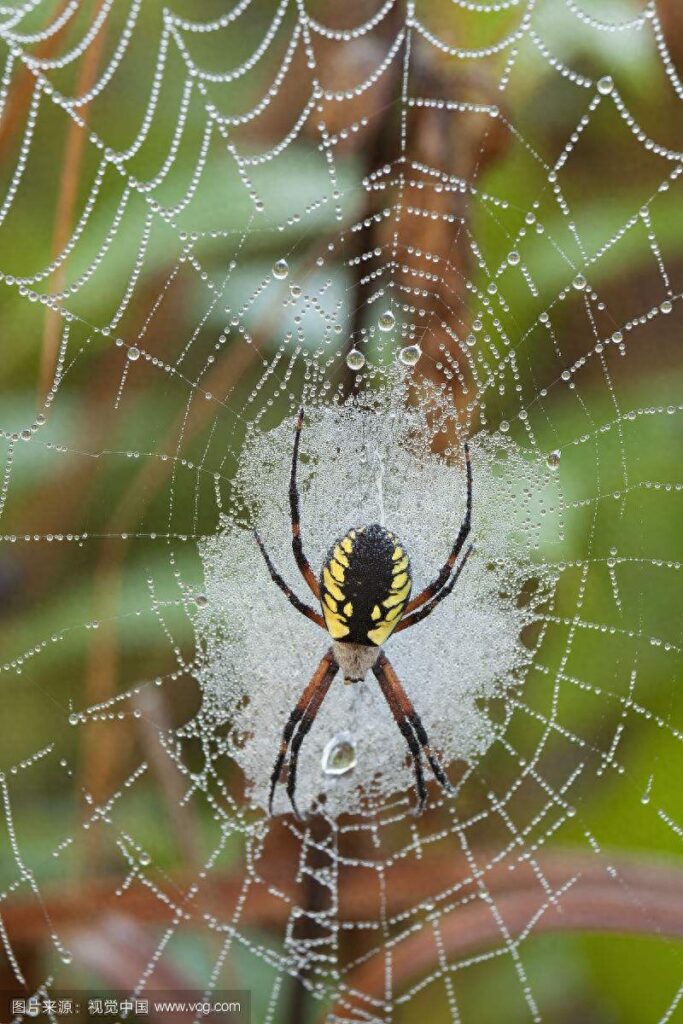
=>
[2,847,683,950]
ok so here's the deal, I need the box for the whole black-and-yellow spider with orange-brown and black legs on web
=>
[254,407,472,818]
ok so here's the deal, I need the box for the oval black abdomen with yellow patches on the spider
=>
[321,523,412,647]
